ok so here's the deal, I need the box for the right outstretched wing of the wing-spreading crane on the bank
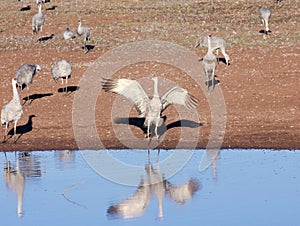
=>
[161,86,198,112]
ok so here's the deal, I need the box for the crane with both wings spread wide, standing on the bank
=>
[101,77,198,142]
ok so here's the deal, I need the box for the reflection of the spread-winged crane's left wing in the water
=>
[107,181,151,219]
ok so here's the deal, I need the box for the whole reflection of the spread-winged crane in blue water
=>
[107,154,201,219]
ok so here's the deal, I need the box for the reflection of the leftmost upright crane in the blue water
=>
[3,153,25,217]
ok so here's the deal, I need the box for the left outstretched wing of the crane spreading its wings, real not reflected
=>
[101,78,149,116]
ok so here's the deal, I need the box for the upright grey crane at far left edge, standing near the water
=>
[1,78,23,142]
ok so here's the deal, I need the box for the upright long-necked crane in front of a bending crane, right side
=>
[202,35,218,89]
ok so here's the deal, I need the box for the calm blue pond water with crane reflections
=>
[0,150,300,226]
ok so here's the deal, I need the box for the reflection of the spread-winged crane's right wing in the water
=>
[166,179,200,204]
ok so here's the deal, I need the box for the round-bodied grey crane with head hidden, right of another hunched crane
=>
[51,60,72,94]
